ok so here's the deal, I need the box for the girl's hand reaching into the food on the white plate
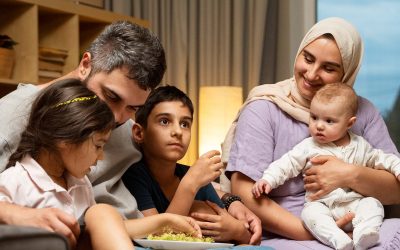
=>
[165,213,202,238]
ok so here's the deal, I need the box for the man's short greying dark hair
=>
[87,21,167,90]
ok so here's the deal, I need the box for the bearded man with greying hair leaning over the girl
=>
[0,21,261,247]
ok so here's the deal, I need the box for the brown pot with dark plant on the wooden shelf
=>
[0,35,17,78]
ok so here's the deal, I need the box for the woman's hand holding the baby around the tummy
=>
[304,155,355,200]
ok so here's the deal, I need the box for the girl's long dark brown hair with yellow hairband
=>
[7,79,115,167]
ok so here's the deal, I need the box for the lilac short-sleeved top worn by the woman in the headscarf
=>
[226,97,399,217]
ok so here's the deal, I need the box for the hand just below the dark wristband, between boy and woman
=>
[228,201,262,245]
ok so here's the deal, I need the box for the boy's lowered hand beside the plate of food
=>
[191,201,251,244]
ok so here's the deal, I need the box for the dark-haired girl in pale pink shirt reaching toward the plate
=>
[0,79,200,249]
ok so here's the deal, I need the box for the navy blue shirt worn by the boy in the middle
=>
[122,159,224,213]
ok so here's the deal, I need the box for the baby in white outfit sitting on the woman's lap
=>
[252,83,400,249]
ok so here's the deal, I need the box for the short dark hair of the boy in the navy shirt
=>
[135,85,194,128]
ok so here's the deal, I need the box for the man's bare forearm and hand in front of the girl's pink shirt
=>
[0,202,80,248]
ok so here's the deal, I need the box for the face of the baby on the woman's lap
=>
[309,98,351,146]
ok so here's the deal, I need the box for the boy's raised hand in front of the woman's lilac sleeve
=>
[183,150,223,188]
